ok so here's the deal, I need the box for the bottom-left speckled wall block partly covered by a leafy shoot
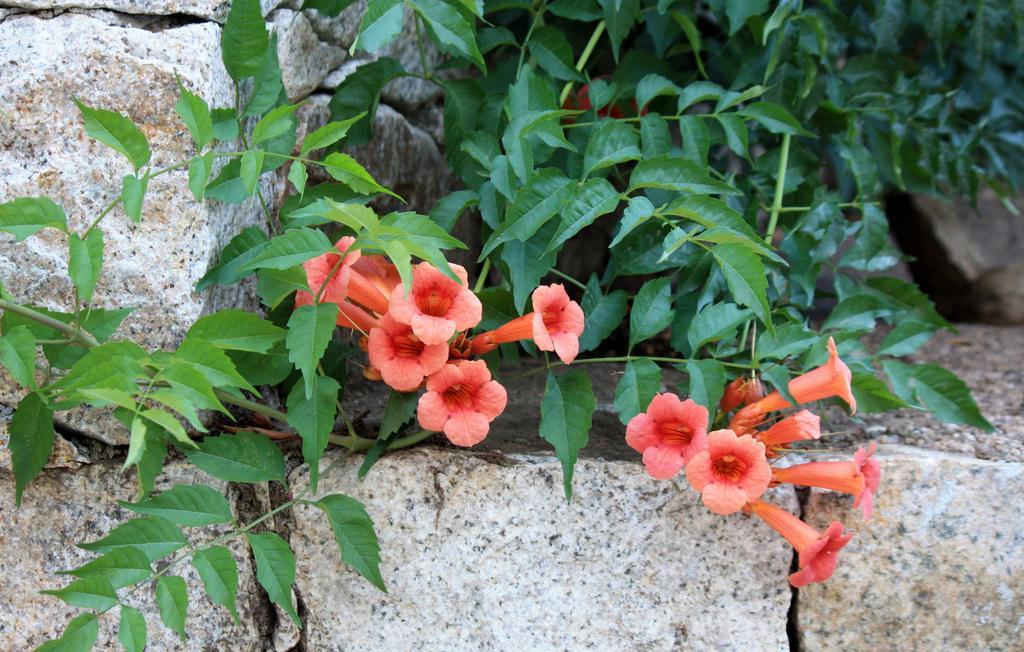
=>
[0,463,267,651]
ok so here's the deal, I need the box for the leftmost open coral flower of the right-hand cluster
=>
[626,394,708,480]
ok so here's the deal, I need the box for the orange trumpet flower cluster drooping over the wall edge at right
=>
[626,339,882,586]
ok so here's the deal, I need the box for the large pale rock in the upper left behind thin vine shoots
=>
[0,14,260,442]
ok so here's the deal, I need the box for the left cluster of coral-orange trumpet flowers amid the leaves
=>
[296,237,584,446]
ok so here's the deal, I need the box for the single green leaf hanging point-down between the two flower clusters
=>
[541,370,597,501]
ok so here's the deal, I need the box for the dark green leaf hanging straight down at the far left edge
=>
[7,392,53,505]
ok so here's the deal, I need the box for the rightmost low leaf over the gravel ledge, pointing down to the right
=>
[882,359,994,432]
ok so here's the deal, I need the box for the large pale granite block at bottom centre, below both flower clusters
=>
[291,448,794,650]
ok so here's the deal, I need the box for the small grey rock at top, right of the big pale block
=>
[269,9,345,101]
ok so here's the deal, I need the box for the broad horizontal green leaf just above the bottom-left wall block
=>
[185,432,285,482]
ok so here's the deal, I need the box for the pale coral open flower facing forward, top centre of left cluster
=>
[390,263,483,344]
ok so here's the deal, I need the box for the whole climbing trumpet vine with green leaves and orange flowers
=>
[0,0,1011,650]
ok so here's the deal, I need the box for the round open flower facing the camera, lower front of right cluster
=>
[686,430,771,515]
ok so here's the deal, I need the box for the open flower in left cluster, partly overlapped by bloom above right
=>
[367,314,449,392]
